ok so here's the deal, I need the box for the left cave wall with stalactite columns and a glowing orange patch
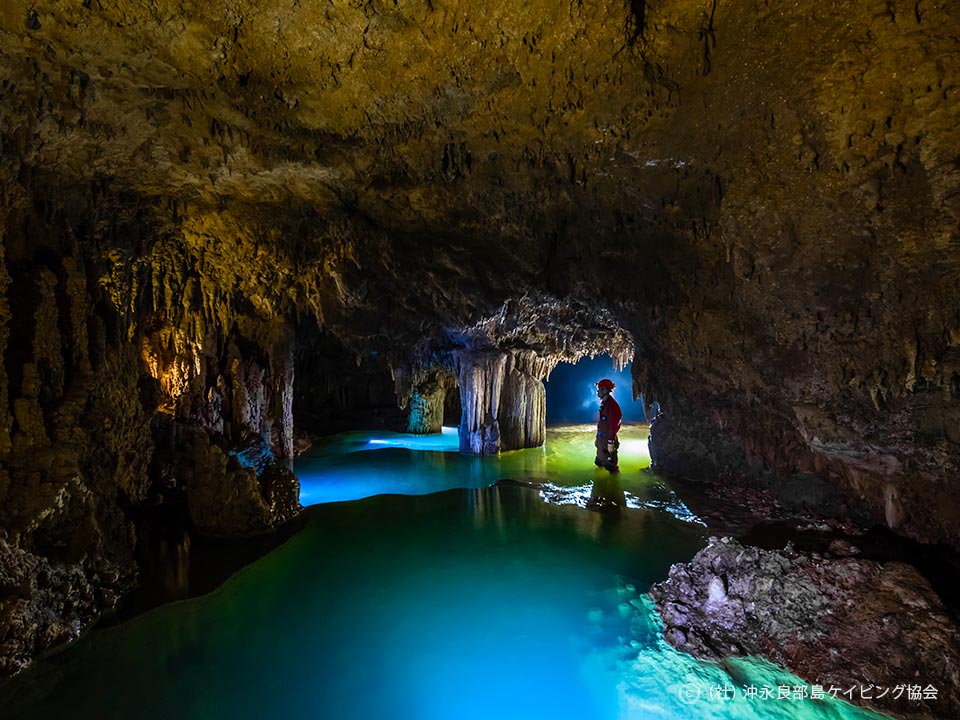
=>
[0,174,299,675]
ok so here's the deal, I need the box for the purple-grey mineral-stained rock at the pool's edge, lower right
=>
[650,537,960,718]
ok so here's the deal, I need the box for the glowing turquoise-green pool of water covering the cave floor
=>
[0,430,876,720]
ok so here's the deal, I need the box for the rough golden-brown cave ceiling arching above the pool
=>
[0,0,960,403]
